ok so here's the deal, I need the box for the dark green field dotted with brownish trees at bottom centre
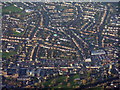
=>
[42,74,79,88]
